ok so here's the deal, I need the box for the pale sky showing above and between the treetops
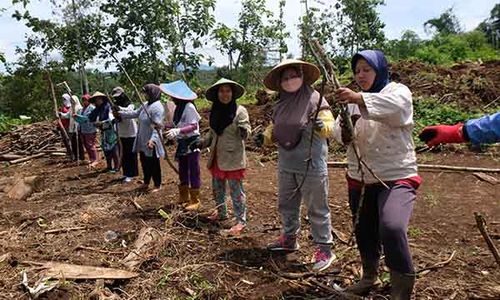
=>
[0,0,498,71]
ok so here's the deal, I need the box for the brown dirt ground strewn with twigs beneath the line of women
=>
[0,137,500,299]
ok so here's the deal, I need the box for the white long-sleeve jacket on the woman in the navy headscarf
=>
[334,82,417,184]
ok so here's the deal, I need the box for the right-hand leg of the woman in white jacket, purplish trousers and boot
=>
[379,184,416,300]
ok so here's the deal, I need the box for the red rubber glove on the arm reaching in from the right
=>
[418,123,466,147]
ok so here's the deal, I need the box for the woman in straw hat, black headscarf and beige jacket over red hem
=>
[192,78,251,235]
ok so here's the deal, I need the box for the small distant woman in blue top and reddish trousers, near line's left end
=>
[75,94,97,168]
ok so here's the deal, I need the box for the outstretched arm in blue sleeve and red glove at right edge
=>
[418,112,500,147]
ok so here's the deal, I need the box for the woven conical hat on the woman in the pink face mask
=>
[264,59,321,91]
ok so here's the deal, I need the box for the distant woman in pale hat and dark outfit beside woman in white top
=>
[88,92,120,173]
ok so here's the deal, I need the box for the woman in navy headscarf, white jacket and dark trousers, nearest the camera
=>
[335,50,421,300]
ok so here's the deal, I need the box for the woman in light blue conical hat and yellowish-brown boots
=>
[160,80,201,211]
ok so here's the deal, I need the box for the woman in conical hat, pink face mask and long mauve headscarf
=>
[263,59,335,271]
